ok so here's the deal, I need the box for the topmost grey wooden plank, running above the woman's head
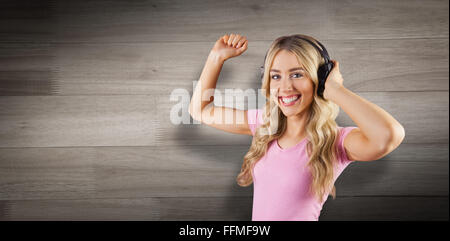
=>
[0,0,449,43]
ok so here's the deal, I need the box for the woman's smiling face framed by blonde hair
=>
[270,49,314,117]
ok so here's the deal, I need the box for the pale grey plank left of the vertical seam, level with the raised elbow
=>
[0,95,158,146]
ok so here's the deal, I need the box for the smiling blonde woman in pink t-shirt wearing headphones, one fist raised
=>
[189,34,405,220]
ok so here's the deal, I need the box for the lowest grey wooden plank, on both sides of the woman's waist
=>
[0,197,448,221]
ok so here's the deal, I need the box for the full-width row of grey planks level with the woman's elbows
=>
[0,91,449,147]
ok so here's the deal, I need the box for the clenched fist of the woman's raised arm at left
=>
[211,33,248,61]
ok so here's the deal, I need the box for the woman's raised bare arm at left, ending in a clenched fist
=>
[189,34,252,135]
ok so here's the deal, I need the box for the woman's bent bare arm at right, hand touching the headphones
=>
[324,61,405,161]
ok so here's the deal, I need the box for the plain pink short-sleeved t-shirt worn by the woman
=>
[247,109,356,221]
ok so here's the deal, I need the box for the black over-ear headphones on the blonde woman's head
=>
[261,35,334,98]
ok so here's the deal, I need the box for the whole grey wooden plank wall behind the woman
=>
[0,0,449,220]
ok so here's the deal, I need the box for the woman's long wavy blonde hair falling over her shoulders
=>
[236,34,339,202]
